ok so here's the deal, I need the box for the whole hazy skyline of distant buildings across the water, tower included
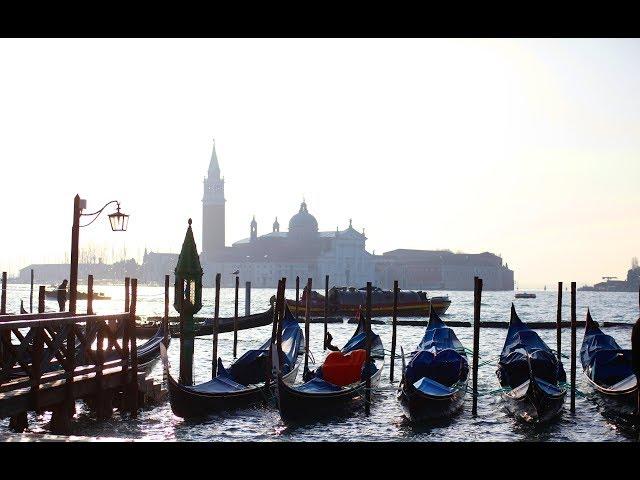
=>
[13,139,514,290]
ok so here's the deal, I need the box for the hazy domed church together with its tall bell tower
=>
[201,144,375,289]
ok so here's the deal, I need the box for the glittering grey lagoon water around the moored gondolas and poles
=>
[0,285,638,442]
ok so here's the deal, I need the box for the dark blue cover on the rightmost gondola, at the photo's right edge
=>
[580,310,633,387]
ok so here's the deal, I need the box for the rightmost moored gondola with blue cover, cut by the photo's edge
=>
[580,310,638,415]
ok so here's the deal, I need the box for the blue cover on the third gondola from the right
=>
[404,310,469,395]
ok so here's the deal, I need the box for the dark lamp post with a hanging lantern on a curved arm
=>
[69,195,129,314]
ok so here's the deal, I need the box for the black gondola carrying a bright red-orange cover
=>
[274,315,384,422]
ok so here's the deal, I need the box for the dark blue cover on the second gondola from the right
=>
[496,304,567,388]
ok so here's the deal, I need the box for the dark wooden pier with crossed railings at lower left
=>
[0,279,160,435]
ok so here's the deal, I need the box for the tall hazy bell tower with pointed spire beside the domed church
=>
[202,140,226,260]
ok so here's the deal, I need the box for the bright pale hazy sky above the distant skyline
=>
[0,39,640,288]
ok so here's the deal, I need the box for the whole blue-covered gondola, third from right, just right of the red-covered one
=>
[396,311,469,422]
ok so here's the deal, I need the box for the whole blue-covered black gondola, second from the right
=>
[496,303,567,423]
